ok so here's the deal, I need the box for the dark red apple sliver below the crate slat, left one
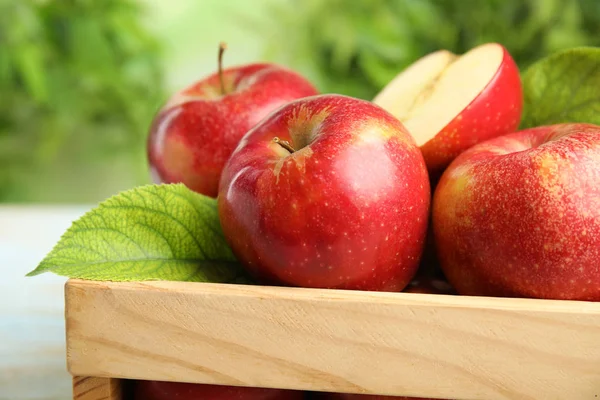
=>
[133,381,304,400]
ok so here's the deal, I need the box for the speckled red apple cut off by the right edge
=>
[433,124,600,301]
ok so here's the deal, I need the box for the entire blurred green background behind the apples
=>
[0,0,600,203]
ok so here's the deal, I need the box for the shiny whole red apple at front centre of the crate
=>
[218,94,430,291]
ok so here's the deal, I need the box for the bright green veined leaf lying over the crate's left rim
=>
[28,184,247,282]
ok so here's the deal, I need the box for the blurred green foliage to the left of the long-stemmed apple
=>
[0,0,162,202]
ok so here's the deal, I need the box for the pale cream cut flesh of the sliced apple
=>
[373,43,504,146]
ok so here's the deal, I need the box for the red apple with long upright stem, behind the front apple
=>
[147,43,317,197]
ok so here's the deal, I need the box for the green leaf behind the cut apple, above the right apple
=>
[521,47,600,128]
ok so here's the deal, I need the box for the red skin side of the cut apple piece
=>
[421,45,523,181]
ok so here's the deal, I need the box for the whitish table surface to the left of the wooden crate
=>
[0,204,91,400]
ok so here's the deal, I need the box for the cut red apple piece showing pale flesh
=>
[373,43,523,179]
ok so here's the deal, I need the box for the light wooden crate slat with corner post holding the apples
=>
[66,280,600,400]
